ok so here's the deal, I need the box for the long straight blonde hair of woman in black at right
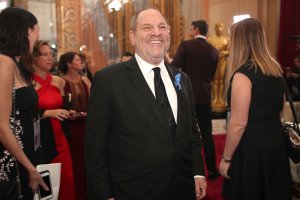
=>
[229,18,283,77]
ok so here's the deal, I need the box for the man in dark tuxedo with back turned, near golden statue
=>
[171,20,220,179]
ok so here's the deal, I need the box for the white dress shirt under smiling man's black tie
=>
[135,53,178,123]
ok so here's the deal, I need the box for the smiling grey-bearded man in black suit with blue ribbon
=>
[86,8,207,200]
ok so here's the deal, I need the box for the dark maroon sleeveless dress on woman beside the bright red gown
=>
[65,79,89,200]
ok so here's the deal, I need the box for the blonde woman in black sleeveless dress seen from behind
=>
[220,18,292,200]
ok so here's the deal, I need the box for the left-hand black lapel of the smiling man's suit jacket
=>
[126,58,171,136]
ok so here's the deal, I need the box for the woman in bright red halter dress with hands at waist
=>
[33,41,75,200]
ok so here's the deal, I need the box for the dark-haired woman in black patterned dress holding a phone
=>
[0,8,47,200]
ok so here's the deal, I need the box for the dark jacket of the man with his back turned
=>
[171,38,219,105]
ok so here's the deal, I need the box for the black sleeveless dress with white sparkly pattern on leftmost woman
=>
[0,86,44,200]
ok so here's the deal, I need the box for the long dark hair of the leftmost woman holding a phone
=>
[0,7,38,83]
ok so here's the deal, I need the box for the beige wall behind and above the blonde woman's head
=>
[207,0,280,56]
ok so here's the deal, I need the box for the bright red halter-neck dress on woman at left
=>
[33,74,76,200]
